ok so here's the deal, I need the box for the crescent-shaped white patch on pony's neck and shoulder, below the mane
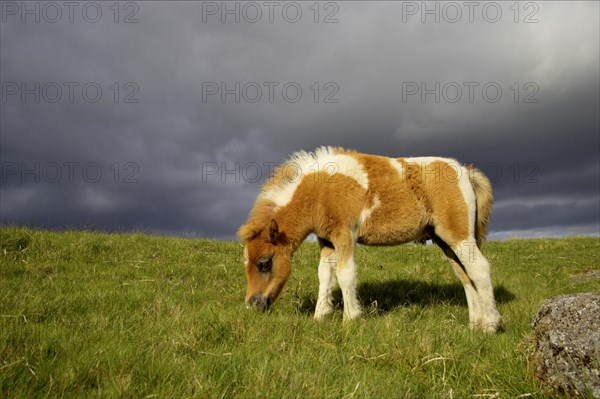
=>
[259,147,369,207]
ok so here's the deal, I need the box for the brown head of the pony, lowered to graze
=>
[238,219,292,310]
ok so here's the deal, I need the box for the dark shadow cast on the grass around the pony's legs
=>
[297,279,516,313]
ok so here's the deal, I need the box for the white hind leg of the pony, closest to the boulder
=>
[455,240,502,332]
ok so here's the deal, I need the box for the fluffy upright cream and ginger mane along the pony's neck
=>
[238,146,356,241]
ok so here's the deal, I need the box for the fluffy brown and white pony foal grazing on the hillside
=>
[238,147,502,332]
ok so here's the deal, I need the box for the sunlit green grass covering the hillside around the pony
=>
[0,227,600,398]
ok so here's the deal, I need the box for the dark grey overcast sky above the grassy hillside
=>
[0,1,600,239]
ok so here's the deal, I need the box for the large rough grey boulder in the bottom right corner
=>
[525,293,600,399]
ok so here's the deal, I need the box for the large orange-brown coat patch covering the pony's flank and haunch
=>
[355,154,469,245]
